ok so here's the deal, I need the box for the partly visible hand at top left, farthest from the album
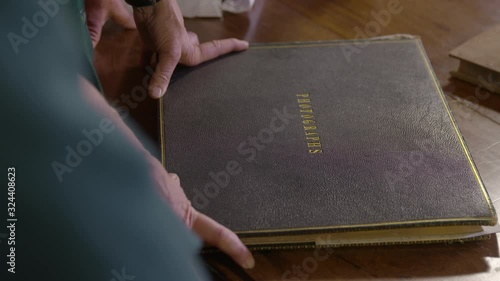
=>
[85,0,136,48]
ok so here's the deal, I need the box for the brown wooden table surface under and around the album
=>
[96,0,500,280]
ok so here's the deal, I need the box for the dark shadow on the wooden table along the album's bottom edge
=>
[205,235,500,281]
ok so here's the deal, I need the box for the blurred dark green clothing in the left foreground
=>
[0,0,207,281]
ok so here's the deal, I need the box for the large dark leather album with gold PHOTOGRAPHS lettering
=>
[160,37,497,249]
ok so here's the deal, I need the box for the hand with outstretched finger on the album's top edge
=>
[134,0,248,98]
